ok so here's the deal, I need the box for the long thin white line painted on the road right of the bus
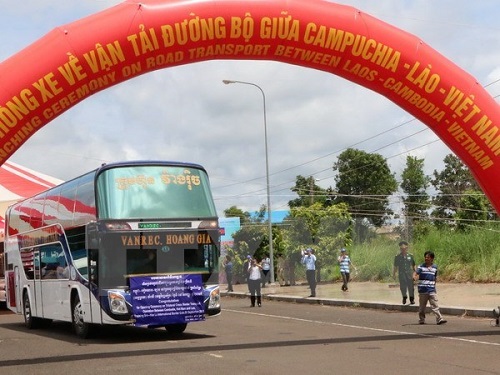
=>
[224,309,500,346]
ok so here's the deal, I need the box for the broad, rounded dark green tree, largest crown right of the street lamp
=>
[333,148,398,227]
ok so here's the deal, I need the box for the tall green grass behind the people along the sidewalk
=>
[322,226,500,283]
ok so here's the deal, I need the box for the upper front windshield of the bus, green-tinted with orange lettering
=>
[96,165,217,219]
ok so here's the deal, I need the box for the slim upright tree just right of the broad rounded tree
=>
[400,156,431,239]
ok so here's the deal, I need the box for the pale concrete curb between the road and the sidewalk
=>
[221,292,495,319]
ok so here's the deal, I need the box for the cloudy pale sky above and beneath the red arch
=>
[0,0,500,216]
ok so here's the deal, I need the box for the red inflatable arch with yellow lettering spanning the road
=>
[0,0,500,212]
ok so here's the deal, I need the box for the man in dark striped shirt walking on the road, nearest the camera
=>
[413,250,447,324]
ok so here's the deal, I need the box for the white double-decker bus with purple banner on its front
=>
[4,161,221,338]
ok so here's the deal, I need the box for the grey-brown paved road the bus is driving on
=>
[0,297,500,375]
